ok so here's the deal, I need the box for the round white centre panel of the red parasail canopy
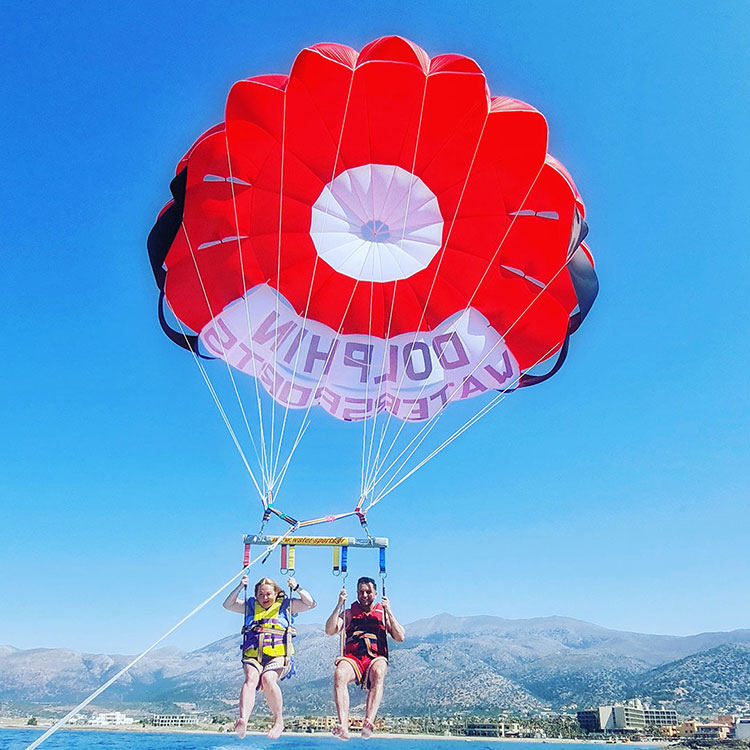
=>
[310,164,443,282]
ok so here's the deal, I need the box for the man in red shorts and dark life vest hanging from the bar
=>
[325,577,406,740]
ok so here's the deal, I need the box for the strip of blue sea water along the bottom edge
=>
[0,729,657,750]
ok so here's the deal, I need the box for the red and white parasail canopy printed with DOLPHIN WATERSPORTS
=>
[149,37,598,516]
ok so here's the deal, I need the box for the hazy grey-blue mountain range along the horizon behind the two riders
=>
[0,614,750,715]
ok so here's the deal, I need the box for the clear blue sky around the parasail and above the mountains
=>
[0,0,750,652]
